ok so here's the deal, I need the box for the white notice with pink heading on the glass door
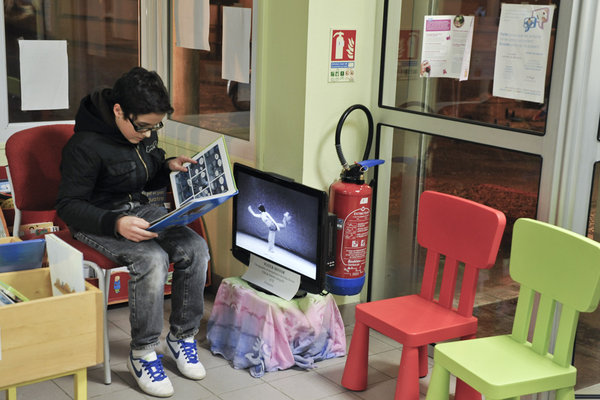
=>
[420,15,474,81]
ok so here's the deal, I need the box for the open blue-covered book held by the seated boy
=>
[148,136,237,232]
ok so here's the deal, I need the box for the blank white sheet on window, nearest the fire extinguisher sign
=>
[221,7,252,83]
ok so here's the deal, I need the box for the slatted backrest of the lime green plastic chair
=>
[510,218,600,366]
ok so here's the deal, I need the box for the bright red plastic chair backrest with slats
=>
[417,191,506,316]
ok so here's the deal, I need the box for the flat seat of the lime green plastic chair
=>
[435,335,577,399]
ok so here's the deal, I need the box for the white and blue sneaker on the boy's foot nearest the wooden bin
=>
[127,351,175,397]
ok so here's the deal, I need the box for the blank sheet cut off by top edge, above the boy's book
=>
[173,0,210,51]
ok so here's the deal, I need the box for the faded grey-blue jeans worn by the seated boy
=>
[75,205,210,350]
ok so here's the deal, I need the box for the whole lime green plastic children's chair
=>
[427,218,600,400]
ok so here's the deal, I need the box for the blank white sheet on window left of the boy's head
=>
[19,40,69,111]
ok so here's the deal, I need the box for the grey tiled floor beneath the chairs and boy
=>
[0,293,597,400]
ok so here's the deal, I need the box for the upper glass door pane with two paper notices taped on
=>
[380,0,559,134]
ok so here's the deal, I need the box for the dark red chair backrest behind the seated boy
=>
[6,124,73,211]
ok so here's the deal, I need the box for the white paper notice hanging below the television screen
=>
[242,254,300,300]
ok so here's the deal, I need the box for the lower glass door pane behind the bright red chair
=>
[382,129,542,336]
